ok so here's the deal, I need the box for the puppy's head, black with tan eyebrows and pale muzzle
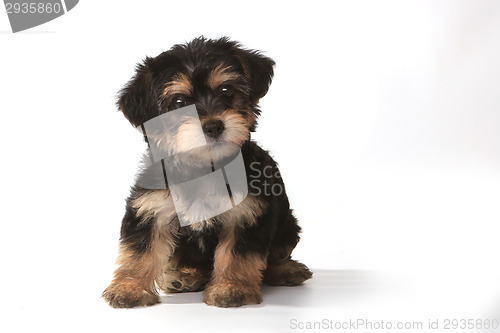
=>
[118,37,274,156]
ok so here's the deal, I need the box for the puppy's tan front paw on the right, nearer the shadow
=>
[204,283,262,308]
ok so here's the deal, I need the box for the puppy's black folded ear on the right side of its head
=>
[237,49,275,104]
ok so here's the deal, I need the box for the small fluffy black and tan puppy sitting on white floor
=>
[103,37,312,307]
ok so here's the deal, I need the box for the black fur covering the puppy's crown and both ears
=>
[117,37,275,126]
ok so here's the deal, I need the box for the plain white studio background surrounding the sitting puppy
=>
[0,1,500,332]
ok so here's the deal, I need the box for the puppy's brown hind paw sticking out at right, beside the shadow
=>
[262,257,312,286]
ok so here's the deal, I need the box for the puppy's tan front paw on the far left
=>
[102,283,160,308]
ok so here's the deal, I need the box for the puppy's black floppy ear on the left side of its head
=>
[117,57,158,127]
